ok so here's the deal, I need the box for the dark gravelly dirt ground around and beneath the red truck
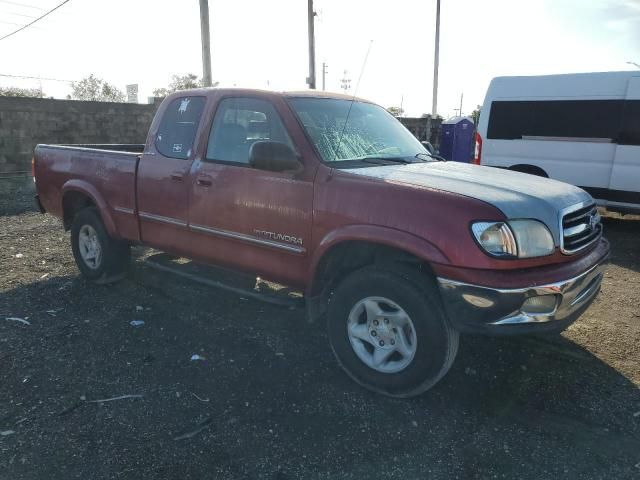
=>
[0,181,640,480]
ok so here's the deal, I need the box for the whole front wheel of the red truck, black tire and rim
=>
[327,266,459,398]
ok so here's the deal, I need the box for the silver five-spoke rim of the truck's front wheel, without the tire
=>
[347,297,418,373]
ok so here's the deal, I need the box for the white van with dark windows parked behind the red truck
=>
[474,70,640,213]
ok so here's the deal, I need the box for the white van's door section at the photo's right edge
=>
[608,76,640,206]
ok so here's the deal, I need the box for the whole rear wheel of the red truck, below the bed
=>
[71,207,131,283]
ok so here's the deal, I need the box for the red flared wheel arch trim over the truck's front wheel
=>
[307,225,449,293]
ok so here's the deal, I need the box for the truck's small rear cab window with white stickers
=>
[156,97,206,159]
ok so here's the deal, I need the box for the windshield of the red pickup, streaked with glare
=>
[290,98,428,162]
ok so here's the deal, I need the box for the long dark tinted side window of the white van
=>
[487,100,625,142]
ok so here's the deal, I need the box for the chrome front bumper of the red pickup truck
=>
[438,255,608,335]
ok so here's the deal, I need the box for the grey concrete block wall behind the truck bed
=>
[0,97,158,176]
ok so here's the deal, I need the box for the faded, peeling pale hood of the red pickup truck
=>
[348,162,593,245]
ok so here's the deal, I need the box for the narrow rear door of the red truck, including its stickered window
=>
[137,96,206,253]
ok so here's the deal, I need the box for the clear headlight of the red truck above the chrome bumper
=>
[471,220,555,258]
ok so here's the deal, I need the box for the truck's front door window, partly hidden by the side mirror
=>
[206,97,293,165]
